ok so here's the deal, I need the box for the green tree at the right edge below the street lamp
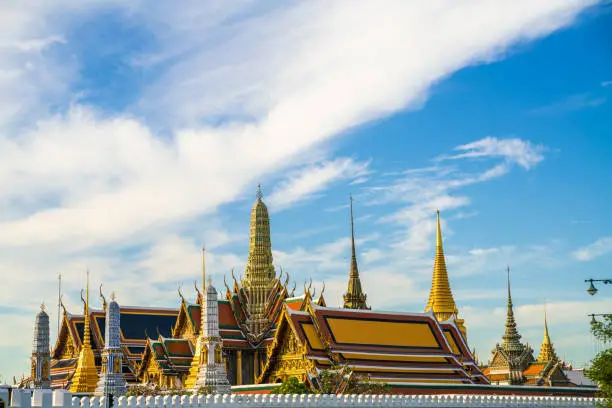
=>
[586,315,612,408]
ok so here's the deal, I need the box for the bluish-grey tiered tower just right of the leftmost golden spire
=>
[94,293,127,397]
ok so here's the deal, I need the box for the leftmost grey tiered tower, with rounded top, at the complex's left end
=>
[30,303,51,388]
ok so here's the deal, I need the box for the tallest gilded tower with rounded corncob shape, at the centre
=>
[242,185,276,337]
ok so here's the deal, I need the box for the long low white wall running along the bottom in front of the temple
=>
[0,389,597,408]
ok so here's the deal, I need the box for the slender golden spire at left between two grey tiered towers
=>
[70,272,98,393]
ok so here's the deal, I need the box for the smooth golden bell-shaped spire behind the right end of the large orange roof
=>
[425,211,467,338]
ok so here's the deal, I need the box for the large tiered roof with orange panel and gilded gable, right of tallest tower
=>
[260,302,487,384]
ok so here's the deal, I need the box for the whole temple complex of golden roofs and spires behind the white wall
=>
[17,188,584,395]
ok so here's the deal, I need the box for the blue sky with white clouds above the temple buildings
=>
[0,0,612,379]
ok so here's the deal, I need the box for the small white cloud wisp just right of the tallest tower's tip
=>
[268,158,370,210]
